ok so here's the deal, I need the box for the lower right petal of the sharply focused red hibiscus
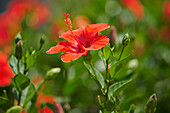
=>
[87,35,109,50]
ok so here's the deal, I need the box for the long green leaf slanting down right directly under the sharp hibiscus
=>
[83,62,105,88]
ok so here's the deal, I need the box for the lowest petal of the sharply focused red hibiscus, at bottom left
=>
[61,51,88,62]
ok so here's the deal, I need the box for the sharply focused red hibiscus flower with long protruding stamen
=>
[47,14,110,62]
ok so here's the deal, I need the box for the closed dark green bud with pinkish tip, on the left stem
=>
[15,40,23,60]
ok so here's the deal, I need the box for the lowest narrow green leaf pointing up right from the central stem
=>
[108,79,132,100]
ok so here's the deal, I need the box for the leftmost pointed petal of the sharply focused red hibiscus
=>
[46,41,70,54]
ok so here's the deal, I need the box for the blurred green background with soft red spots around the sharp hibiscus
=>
[0,0,170,113]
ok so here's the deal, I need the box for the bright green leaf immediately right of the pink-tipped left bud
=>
[26,50,42,70]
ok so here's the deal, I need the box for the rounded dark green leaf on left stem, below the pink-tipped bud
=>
[12,73,30,91]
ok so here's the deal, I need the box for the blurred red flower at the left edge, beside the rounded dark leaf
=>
[0,51,15,87]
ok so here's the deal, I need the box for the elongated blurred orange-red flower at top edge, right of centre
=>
[121,0,144,19]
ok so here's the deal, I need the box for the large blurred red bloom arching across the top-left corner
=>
[0,0,50,47]
